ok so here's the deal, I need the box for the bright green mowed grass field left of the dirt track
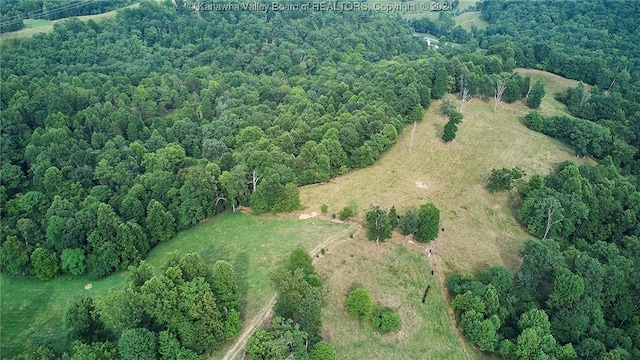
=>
[0,212,349,358]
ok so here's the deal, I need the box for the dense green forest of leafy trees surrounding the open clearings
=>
[0,0,640,359]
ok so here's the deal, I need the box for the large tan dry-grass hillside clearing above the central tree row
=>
[300,79,592,272]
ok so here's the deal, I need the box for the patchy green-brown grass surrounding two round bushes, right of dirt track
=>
[316,232,492,360]
